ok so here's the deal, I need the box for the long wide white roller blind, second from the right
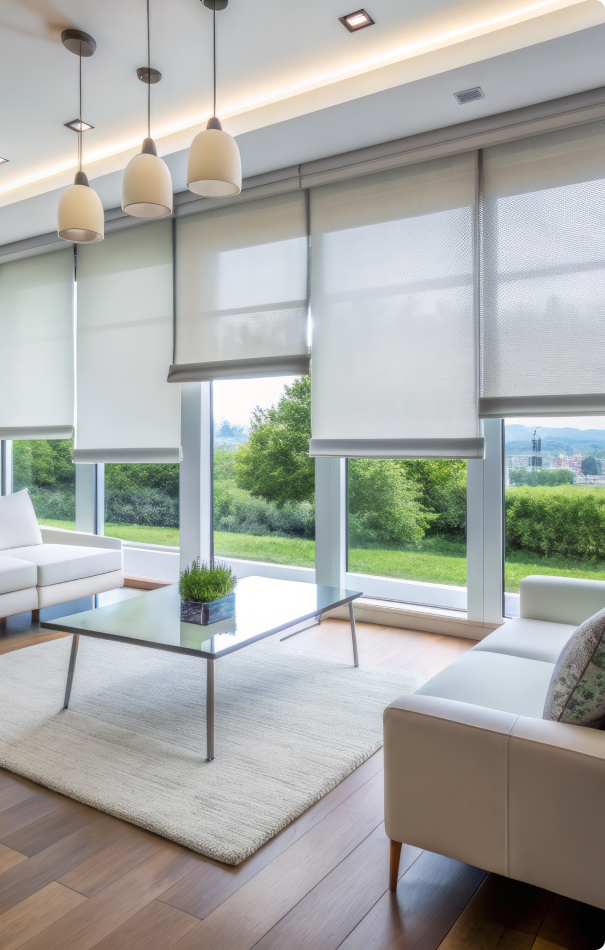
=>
[310,153,483,458]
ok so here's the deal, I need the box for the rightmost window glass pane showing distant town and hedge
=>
[505,416,605,617]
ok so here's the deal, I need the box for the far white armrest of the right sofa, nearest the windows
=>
[519,574,605,626]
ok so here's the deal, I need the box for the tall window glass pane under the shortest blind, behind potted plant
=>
[213,376,315,568]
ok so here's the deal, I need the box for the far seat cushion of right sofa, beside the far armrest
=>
[473,617,576,663]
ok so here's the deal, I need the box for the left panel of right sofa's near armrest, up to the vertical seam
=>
[384,694,517,874]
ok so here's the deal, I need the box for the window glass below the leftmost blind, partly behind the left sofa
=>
[13,439,76,531]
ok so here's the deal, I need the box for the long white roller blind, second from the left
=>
[74,221,180,462]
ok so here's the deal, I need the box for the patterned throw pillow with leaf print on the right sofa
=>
[542,610,605,729]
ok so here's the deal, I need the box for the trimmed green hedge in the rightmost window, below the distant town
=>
[506,485,605,560]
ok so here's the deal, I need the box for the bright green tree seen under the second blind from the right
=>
[349,459,436,544]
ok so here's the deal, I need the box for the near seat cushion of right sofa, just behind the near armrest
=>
[417,650,555,719]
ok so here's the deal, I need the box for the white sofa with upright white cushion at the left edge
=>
[0,489,124,618]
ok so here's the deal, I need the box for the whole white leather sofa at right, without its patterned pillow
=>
[384,577,605,909]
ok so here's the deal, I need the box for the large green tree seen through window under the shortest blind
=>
[235,376,315,505]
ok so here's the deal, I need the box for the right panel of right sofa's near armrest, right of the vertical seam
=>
[509,716,605,909]
